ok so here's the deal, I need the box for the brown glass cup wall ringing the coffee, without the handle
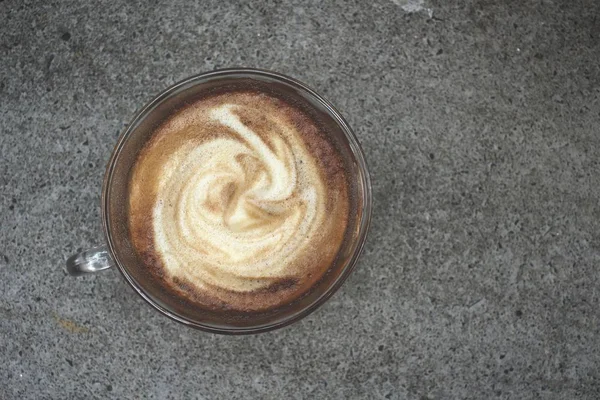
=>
[102,69,371,334]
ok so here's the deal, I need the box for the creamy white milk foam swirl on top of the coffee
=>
[153,104,327,292]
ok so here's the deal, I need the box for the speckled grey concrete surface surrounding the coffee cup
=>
[0,0,600,400]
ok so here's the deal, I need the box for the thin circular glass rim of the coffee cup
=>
[101,68,373,335]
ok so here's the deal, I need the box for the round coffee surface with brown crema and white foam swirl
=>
[128,90,349,312]
